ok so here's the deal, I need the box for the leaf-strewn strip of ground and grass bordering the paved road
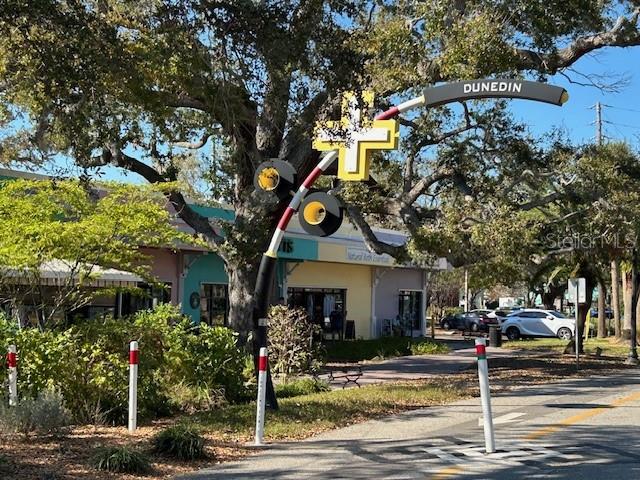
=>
[0,353,628,480]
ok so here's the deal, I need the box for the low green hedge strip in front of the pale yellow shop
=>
[326,337,449,362]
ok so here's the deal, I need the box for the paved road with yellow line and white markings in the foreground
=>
[181,371,640,480]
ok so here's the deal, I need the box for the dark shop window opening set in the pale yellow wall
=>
[287,287,347,326]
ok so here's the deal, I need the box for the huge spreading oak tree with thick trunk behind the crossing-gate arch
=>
[0,0,640,342]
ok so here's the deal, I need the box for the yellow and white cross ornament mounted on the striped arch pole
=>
[313,92,400,182]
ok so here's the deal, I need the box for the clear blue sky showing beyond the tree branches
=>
[28,42,640,183]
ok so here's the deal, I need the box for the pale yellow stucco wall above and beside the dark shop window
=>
[287,256,371,338]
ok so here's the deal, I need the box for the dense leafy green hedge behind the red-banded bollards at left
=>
[0,305,244,424]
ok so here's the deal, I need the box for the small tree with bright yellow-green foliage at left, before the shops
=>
[0,180,193,322]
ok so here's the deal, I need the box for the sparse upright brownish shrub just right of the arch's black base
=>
[269,305,321,375]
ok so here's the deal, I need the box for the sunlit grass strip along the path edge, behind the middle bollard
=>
[194,380,468,440]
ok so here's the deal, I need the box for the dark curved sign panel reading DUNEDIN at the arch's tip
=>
[424,79,569,107]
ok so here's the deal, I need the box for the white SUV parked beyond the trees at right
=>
[500,308,576,340]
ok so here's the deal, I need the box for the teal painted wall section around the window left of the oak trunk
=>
[182,253,228,323]
